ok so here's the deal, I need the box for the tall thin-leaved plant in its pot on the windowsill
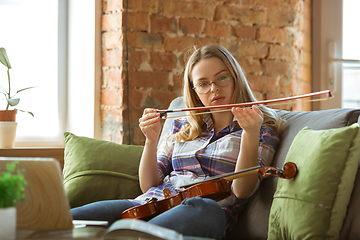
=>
[0,48,34,148]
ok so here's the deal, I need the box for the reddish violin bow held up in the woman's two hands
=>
[157,90,333,119]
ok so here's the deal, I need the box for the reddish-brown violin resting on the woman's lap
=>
[121,162,298,221]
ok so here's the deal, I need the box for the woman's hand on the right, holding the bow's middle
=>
[231,105,264,134]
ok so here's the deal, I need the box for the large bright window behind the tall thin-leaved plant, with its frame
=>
[0,0,101,147]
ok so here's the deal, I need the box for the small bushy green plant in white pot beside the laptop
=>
[0,161,27,239]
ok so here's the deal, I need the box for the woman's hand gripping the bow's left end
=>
[139,108,161,143]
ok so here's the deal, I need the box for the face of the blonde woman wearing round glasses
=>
[191,57,234,106]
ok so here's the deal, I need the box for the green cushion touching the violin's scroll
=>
[268,123,360,240]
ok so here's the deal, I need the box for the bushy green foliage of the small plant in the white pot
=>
[0,161,28,208]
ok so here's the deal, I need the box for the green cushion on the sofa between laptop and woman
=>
[63,132,143,207]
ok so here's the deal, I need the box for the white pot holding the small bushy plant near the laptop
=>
[0,207,16,240]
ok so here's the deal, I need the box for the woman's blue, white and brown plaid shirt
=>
[131,114,280,227]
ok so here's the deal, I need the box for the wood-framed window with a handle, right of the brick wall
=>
[312,0,360,110]
